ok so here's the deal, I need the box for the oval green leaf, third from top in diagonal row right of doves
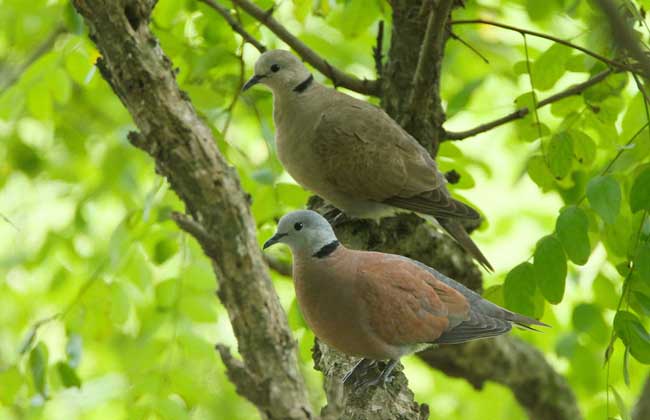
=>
[533,236,567,304]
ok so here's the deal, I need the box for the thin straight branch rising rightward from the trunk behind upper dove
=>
[444,69,614,141]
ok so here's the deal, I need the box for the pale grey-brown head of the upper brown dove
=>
[243,50,312,92]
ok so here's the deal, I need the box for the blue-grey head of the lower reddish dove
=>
[264,210,338,255]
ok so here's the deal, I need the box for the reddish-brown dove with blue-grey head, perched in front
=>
[264,210,547,387]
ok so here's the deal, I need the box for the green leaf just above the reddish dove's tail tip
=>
[503,262,543,317]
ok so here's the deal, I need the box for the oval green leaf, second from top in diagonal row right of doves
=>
[555,206,591,265]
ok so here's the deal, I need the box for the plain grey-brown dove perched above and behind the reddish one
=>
[243,50,492,270]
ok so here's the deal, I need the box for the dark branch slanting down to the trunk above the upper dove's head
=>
[232,0,380,96]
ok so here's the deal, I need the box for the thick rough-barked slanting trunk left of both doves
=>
[73,0,312,420]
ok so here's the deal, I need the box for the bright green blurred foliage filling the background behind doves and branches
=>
[0,0,650,419]
